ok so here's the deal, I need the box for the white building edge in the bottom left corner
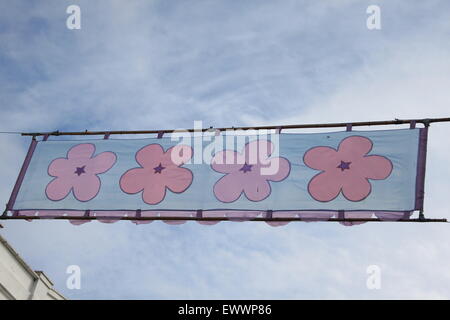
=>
[0,235,66,300]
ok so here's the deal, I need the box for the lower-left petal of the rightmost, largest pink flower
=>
[308,172,341,202]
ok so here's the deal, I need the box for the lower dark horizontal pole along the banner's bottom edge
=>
[0,216,447,222]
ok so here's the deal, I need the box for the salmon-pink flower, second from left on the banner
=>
[120,144,193,204]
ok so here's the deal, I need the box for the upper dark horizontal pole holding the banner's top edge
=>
[22,118,450,137]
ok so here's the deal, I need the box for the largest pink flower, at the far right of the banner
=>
[303,136,392,202]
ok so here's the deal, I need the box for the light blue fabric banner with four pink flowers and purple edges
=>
[7,128,427,225]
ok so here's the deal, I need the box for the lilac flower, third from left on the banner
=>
[211,140,291,202]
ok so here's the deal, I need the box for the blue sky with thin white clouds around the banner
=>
[0,0,450,299]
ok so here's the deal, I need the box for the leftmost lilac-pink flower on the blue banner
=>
[45,143,116,201]
